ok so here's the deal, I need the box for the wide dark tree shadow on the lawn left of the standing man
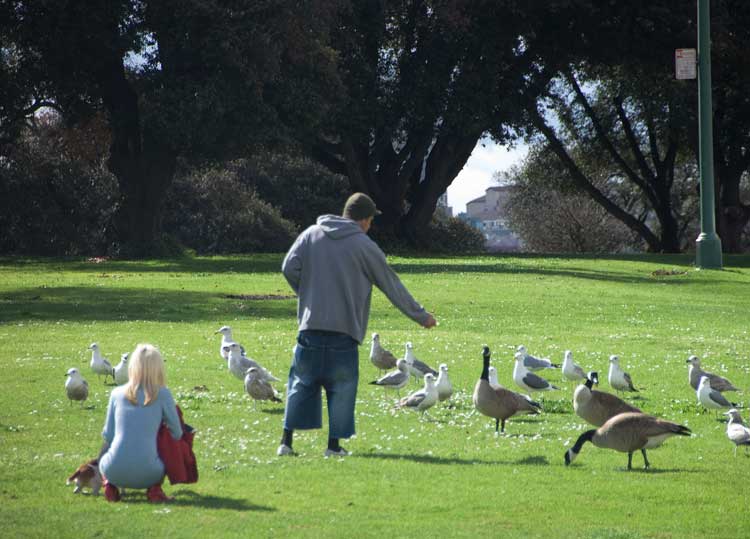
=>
[0,286,297,322]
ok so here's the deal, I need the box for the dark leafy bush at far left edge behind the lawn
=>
[0,115,119,255]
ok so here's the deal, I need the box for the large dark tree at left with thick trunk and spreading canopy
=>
[0,0,337,252]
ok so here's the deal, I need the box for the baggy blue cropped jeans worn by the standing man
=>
[284,330,359,438]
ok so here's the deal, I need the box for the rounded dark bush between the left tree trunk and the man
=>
[162,169,296,253]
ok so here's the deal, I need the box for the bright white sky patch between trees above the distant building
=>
[448,138,526,215]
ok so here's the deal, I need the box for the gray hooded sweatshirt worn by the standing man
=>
[281,215,429,343]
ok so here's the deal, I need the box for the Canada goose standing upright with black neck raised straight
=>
[473,346,542,433]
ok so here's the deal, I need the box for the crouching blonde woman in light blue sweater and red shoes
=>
[99,344,182,502]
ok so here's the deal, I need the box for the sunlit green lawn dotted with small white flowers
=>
[0,255,750,539]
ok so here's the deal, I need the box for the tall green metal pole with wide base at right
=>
[695,0,722,269]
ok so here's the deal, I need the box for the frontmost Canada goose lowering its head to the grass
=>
[565,412,690,470]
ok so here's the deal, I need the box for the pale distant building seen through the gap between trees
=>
[461,185,521,251]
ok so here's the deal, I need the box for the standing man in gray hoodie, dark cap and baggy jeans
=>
[277,193,437,457]
